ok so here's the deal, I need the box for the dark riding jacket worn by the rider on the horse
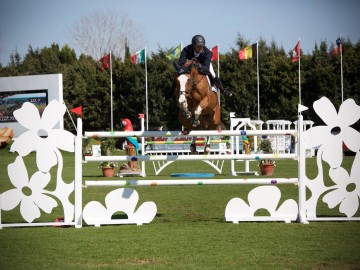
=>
[178,44,212,75]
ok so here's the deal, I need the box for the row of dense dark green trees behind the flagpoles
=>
[0,35,360,131]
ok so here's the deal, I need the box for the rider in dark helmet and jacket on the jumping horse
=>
[178,35,232,96]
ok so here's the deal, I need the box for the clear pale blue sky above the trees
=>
[0,0,360,66]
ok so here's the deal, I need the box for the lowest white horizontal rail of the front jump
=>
[85,178,298,187]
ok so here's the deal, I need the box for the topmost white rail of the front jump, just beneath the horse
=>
[85,129,297,138]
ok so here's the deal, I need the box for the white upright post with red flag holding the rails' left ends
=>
[74,118,82,228]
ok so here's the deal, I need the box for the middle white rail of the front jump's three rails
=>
[85,154,297,162]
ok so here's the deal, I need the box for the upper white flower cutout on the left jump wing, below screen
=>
[10,100,75,172]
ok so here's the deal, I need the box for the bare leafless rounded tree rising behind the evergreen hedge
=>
[68,10,145,59]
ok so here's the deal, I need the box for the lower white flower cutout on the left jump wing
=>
[0,157,57,223]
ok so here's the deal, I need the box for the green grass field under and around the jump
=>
[0,149,360,269]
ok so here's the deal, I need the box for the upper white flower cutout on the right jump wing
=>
[306,97,360,168]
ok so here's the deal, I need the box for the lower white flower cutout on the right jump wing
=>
[323,153,360,218]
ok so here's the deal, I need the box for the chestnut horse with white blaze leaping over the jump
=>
[174,59,224,154]
